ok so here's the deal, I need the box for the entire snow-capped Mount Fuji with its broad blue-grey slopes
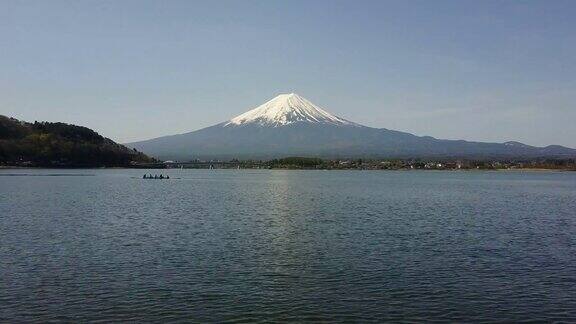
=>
[126,93,576,160]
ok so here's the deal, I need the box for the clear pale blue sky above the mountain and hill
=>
[0,0,576,147]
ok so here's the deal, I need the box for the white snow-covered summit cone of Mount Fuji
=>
[224,93,357,127]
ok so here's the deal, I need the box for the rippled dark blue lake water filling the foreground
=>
[0,170,576,323]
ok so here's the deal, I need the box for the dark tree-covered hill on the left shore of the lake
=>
[0,115,154,167]
